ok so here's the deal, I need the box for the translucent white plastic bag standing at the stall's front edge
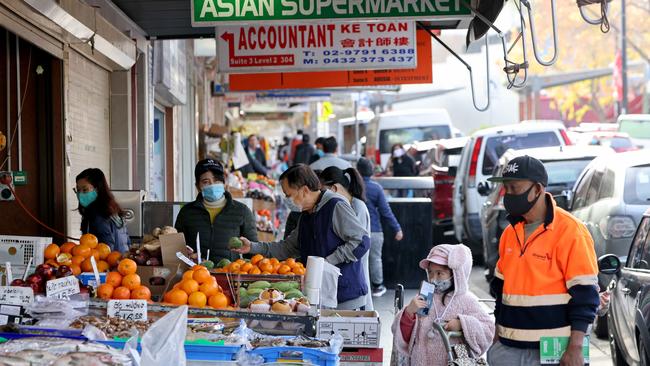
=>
[140,305,188,366]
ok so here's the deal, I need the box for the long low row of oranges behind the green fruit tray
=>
[215,253,305,276]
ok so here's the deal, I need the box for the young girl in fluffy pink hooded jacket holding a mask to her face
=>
[392,244,494,366]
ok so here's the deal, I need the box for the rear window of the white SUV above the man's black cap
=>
[482,131,560,175]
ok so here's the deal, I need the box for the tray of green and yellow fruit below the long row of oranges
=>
[239,281,305,308]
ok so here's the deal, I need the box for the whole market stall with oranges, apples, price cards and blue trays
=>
[0,233,381,365]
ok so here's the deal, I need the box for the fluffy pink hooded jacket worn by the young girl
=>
[392,244,495,366]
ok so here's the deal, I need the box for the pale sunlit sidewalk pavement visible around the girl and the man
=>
[373,267,612,366]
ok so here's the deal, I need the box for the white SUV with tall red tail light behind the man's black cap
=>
[453,121,571,263]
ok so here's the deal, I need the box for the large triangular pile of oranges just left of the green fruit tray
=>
[163,265,232,309]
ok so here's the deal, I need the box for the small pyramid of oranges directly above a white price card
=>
[97,258,151,300]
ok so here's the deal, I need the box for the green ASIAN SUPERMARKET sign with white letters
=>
[191,0,470,27]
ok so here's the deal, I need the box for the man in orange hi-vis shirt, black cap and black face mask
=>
[488,156,599,366]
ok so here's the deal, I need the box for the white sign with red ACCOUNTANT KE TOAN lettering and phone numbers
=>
[216,21,417,73]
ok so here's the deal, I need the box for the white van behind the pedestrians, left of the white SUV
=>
[366,109,452,169]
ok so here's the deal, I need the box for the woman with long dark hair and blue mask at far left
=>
[74,168,131,253]
